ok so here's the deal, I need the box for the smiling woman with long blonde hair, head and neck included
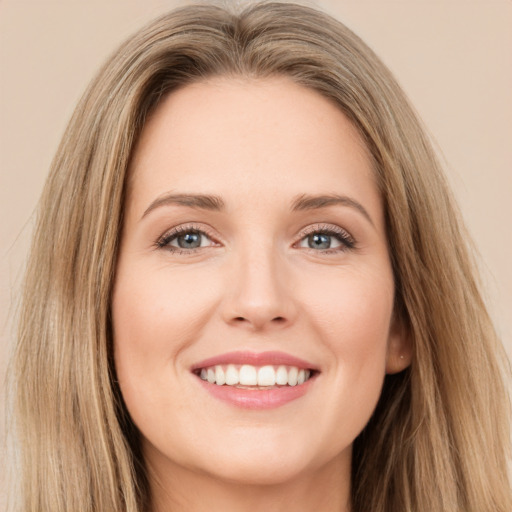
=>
[10,3,512,512]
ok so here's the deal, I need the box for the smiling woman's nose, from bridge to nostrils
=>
[223,248,297,331]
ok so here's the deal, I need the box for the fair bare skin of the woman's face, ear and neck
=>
[112,78,410,512]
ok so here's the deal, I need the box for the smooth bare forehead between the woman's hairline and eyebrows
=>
[126,78,380,225]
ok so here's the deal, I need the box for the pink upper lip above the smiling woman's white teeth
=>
[191,351,319,371]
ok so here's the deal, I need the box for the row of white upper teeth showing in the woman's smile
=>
[199,364,311,387]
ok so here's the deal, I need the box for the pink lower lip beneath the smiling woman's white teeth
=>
[197,375,317,409]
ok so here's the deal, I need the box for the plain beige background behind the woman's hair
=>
[0,0,512,508]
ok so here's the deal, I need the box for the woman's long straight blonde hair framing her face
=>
[12,3,512,512]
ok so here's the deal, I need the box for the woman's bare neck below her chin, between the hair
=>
[149,448,350,512]
